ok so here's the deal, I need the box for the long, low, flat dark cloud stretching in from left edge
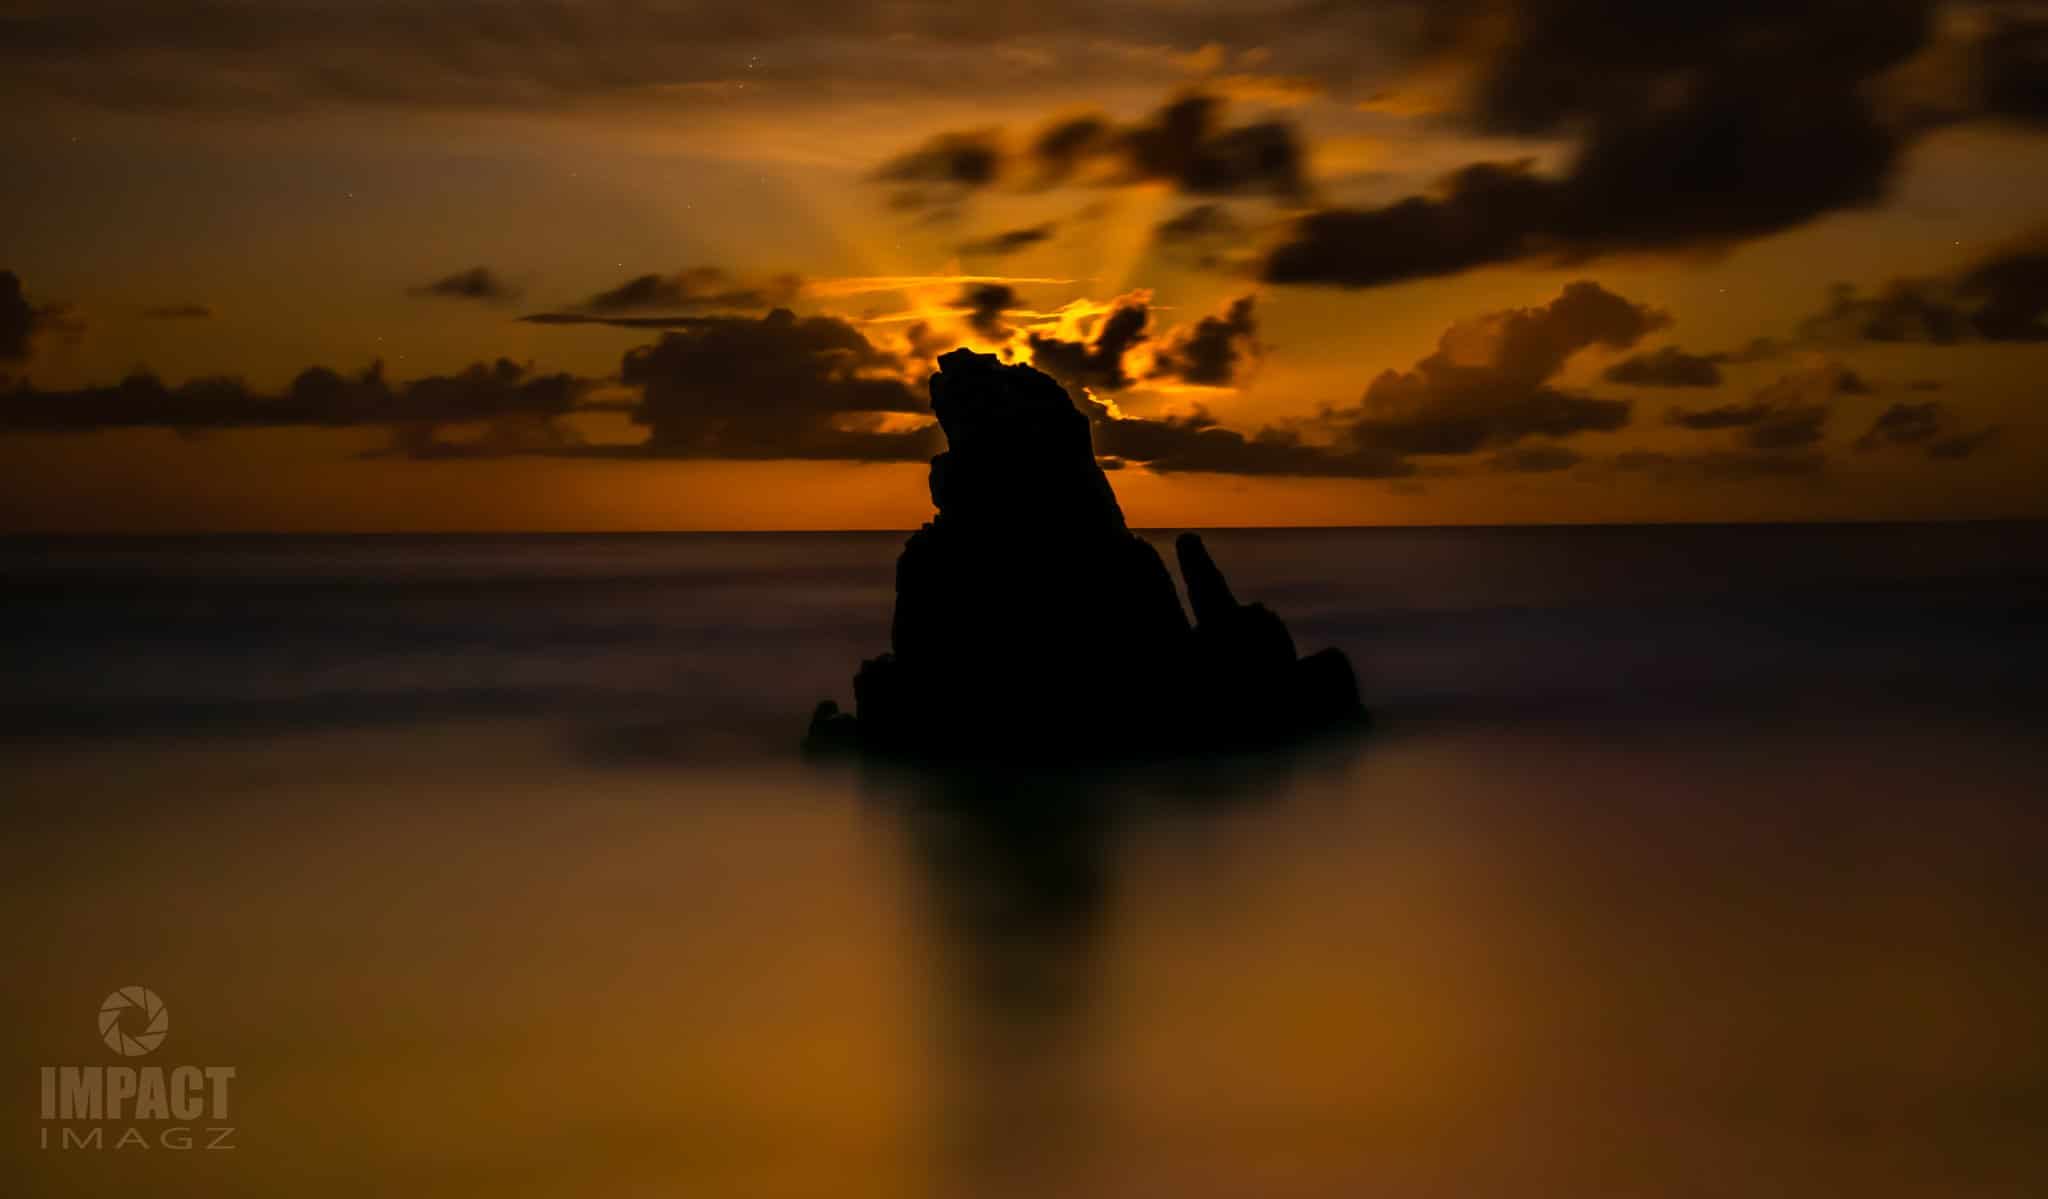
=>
[0,359,586,432]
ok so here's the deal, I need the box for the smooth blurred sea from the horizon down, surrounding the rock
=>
[0,525,2048,1197]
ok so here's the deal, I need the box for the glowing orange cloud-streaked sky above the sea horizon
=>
[0,0,2048,531]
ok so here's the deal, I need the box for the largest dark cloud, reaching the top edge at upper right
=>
[1266,0,1931,287]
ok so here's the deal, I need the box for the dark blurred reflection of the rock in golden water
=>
[860,740,1358,1199]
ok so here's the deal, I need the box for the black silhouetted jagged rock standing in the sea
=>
[807,350,1364,760]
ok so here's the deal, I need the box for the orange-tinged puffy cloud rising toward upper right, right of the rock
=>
[1325,281,1669,455]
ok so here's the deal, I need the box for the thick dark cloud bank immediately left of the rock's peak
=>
[618,307,940,461]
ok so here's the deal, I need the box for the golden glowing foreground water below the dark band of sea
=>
[0,711,2048,1199]
